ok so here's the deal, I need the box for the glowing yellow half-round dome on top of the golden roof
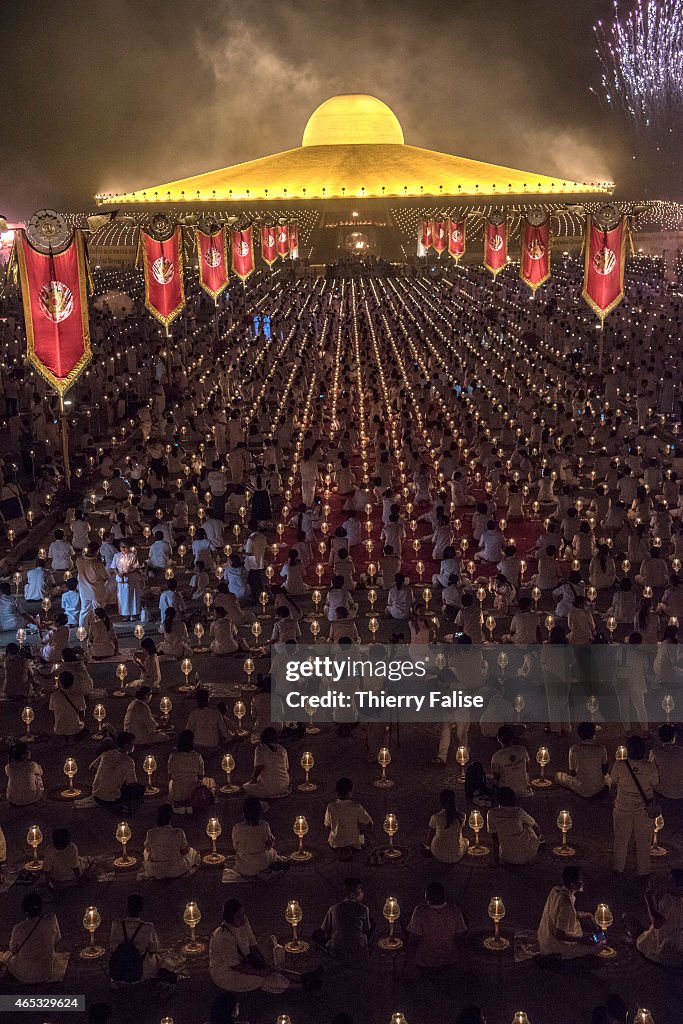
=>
[301,93,403,145]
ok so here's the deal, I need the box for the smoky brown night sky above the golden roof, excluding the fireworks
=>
[0,0,679,219]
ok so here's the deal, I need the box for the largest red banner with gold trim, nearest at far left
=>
[15,230,90,395]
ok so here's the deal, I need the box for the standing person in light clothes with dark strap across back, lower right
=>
[611,736,659,877]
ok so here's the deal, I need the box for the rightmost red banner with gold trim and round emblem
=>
[582,214,629,321]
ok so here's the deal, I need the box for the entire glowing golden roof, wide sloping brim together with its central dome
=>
[95,94,611,204]
